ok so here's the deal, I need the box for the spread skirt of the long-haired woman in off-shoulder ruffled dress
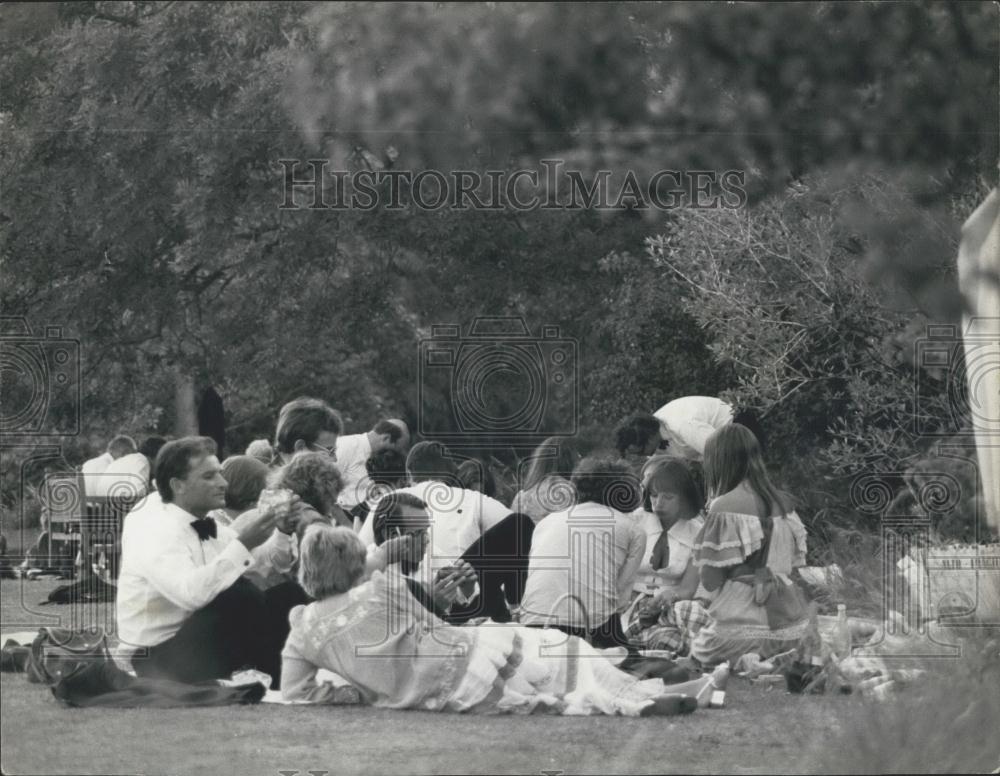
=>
[691,580,809,666]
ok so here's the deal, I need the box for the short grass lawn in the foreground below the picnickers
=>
[0,580,984,776]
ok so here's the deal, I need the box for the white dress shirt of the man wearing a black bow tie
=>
[116,502,253,647]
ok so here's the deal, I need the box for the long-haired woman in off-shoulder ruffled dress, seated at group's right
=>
[691,423,809,665]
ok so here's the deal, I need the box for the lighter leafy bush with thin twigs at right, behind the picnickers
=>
[647,176,992,539]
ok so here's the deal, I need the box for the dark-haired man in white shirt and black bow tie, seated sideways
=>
[117,437,301,682]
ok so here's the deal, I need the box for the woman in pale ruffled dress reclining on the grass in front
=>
[282,520,711,716]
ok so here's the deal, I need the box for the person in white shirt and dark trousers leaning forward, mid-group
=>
[360,442,534,622]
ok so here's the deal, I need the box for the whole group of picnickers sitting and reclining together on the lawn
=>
[111,397,808,716]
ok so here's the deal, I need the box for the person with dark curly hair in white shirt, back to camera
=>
[519,458,646,647]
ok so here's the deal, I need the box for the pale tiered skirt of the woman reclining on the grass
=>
[445,623,669,717]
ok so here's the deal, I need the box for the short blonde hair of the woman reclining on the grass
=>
[299,523,365,600]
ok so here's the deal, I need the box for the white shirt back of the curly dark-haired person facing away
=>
[519,502,646,630]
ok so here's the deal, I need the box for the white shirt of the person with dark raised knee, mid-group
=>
[359,480,510,571]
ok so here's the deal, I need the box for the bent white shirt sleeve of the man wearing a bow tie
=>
[138,537,253,612]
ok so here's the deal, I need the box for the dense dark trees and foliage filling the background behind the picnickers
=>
[0,2,997,544]
